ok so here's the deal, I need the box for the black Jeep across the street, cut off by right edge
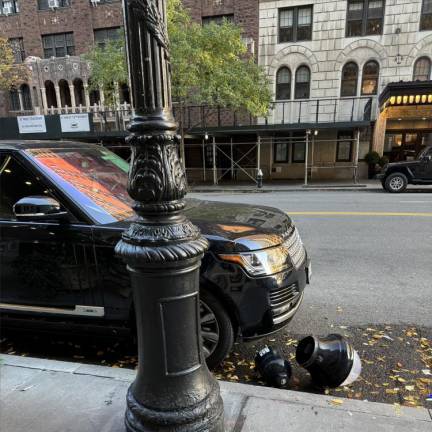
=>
[377,146,432,193]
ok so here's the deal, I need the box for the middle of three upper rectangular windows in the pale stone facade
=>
[346,0,384,37]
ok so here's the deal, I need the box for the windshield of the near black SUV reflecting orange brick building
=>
[26,147,134,224]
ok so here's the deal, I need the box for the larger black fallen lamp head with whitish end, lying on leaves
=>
[296,334,361,388]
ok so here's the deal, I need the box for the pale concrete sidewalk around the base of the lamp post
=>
[0,355,432,432]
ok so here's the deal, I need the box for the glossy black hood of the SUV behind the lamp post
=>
[111,199,292,253]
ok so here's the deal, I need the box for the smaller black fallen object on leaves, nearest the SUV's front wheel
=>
[255,346,291,388]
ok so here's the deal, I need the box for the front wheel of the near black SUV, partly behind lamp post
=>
[200,289,234,369]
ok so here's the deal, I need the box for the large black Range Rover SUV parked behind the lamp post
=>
[0,141,311,367]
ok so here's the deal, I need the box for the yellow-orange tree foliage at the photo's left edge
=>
[0,38,30,90]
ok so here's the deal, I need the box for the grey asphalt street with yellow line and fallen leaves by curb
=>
[0,191,432,408]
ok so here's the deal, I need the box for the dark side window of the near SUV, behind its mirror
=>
[0,153,49,219]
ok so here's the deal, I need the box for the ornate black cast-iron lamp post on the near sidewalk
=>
[116,0,223,432]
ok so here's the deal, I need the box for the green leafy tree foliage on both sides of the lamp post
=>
[84,0,271,121]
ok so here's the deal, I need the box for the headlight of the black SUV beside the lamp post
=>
[219,245,292,276]
